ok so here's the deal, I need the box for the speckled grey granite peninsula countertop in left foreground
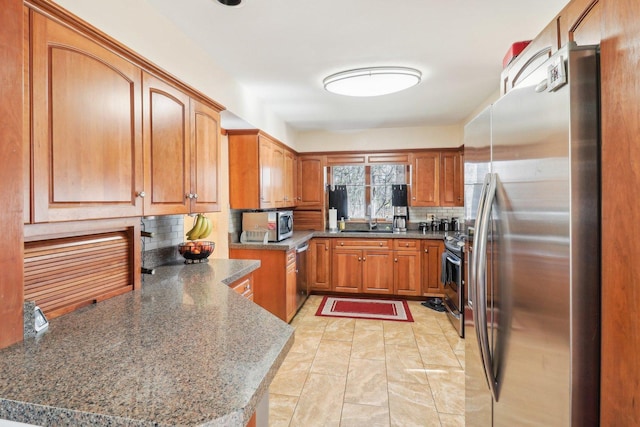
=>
[0,259,294,426]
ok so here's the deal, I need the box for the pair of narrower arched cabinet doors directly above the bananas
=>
[142,72,219,215]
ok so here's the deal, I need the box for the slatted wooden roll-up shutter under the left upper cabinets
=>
[24,231,133,319]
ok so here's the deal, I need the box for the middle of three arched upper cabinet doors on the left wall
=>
[142,73,191,215]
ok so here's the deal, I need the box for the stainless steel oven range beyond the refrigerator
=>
[442,235,464,338]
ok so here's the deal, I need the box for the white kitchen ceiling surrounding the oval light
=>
[148,0,567,131]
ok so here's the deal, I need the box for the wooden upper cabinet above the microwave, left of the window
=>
[227,129,296,209]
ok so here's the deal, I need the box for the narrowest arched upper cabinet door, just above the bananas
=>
[190,99,220,212]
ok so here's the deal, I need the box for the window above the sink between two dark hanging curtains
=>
[331,164,407,220]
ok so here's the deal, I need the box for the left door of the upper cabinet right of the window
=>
[411,152,440,206]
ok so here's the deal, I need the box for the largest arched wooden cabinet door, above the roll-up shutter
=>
[30,12,143,222]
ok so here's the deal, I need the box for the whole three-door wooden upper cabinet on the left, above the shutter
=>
[24,9,220,223]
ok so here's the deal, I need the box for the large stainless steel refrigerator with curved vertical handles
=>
[465,43,600,427]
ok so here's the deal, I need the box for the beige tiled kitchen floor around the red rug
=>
[269,295,464,427]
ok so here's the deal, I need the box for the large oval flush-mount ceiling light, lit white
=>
[322,67,422,96]
